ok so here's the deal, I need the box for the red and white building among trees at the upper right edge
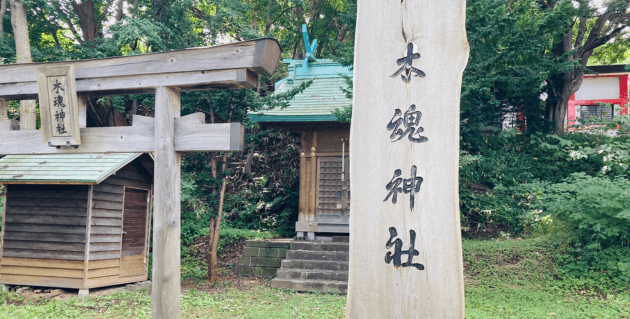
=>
[566,64,630,125]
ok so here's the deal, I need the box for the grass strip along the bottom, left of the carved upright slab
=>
[0,286,346,319]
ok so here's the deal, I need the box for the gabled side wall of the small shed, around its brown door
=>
[87,161,152,288]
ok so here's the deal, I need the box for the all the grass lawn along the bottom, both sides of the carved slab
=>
[0,238,630,319]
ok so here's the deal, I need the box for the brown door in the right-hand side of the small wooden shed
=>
[120,187,150,277]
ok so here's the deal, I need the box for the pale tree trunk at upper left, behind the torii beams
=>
[11,0,37,130]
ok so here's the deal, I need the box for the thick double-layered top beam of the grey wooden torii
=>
[0,38,282,100]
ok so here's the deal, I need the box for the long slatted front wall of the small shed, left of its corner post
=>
[0,185,88,288]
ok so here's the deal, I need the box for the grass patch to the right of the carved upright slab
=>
[463,237,630,319]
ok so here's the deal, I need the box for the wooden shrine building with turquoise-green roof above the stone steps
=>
[249,59,352,240]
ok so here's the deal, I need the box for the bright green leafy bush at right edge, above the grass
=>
[544,173,630,250]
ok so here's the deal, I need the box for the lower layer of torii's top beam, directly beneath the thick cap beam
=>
[0,67,258,100]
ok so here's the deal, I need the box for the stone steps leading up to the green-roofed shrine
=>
[271,237,350,294]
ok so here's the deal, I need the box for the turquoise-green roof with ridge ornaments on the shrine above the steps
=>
[248,60,352,122]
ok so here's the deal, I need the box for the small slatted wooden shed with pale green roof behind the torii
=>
[0,153,153,295]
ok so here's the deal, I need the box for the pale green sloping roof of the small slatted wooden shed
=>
[0,153,142,184]
